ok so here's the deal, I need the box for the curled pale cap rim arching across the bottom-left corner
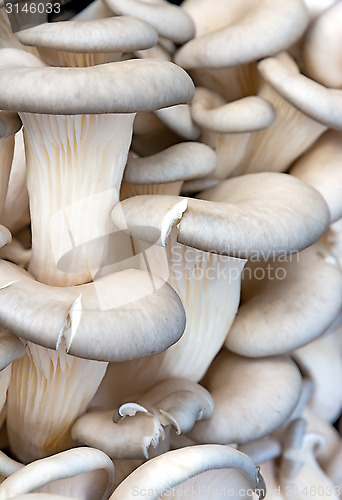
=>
[0,448,114,500]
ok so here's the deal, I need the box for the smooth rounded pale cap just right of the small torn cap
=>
[188,349,302,444]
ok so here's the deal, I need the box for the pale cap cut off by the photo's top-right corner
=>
[302,2,342,89]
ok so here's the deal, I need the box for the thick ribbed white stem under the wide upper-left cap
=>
[22,113,134,286]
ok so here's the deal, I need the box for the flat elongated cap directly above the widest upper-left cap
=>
[17,16,158,53]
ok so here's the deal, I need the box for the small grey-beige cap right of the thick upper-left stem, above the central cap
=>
[124,142,217,184]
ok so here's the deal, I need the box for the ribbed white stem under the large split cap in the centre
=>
[118,230,246,384]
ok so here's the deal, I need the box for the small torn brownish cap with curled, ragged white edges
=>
[72,378,213,459]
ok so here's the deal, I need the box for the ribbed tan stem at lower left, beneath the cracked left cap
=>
[7,342,107,462]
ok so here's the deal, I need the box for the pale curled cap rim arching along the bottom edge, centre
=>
[110,445,265,500]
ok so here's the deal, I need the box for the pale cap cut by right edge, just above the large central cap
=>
[290,130,342,223]
